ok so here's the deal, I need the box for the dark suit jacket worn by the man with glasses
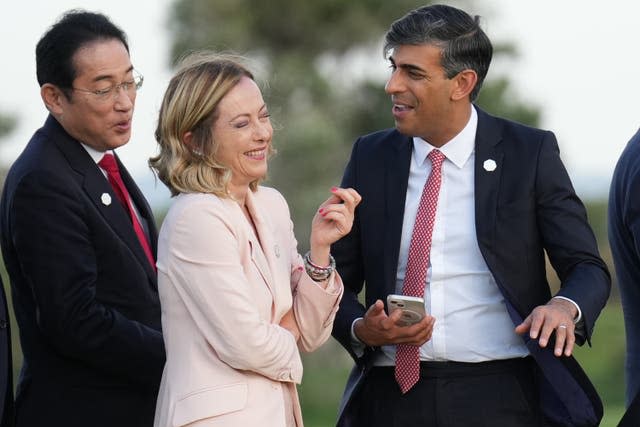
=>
[0,116,165,427]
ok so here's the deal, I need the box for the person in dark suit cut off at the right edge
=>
[609,131,640,426]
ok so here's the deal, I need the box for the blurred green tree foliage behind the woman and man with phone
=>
[169,0,538,250]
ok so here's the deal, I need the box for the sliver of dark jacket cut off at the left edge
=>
[0,277,13,427]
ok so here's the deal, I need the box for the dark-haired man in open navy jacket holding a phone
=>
[332,5,610,427]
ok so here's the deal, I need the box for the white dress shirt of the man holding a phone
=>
[352,107,581,365]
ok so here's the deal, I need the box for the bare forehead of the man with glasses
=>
[73,39,132,80]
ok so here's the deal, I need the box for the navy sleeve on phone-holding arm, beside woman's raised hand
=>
[331,140,367,360]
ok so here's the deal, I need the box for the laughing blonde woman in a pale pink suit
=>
[150,53,360,427]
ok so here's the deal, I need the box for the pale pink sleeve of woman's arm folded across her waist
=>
[165,202,302,383]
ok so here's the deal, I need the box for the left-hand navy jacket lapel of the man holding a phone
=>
[383,134,413,293]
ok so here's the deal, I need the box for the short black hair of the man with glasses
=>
[36,9,129,96]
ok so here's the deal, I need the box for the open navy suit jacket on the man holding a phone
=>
[332,109,610,426]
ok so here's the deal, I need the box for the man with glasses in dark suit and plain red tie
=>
[0,11,165,427]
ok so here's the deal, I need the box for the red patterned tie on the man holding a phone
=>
[395,150,445,394]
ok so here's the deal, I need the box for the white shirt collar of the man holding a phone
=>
[413,105,478,168]
